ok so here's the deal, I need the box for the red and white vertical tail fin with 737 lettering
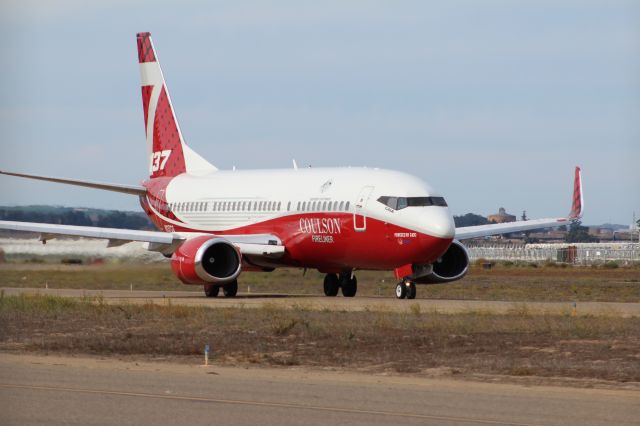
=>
[137,33,216,178]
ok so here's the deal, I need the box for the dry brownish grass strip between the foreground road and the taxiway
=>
[0,295,640,385]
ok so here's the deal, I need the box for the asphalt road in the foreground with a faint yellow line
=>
[0,354,640,426]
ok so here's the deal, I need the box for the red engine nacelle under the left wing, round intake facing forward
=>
[171,235,242,284]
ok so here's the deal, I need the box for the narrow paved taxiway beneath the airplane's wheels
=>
[3,288,640,317]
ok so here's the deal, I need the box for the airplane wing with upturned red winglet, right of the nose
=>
[455,167,584,240]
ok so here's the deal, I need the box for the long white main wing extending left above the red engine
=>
[0,221,285,258]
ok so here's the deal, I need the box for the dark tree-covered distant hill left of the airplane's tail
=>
[0,206,155,230]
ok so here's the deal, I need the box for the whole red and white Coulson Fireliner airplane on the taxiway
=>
[0,33,583,299]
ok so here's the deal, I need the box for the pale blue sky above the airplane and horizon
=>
[0,0,640,224]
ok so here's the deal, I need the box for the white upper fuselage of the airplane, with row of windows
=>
[151,167,455,238]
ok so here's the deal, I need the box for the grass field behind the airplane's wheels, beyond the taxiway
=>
[0,263,640,302]
